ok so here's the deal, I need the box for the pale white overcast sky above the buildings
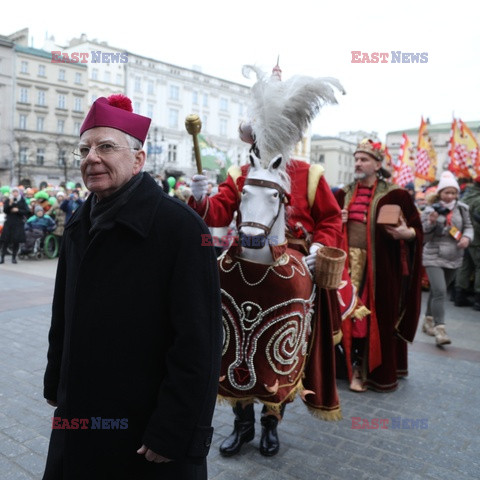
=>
[0,0,480,141]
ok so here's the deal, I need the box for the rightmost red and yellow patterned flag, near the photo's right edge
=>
[448,119,478,178]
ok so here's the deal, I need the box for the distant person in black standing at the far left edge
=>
[0,187,30,263]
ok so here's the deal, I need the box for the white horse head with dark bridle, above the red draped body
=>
[239,153,289,249]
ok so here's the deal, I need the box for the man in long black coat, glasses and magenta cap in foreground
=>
[43,96,222,480]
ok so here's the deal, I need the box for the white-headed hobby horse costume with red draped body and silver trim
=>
[219,154,315,411]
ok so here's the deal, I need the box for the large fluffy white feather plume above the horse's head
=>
[243,65,345,165]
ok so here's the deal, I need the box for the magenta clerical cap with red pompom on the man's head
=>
[80,95,152,145]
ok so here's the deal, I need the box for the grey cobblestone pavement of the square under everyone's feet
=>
[0,257,480,480]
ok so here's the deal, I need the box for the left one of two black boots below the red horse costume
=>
[220,400,255,457]
